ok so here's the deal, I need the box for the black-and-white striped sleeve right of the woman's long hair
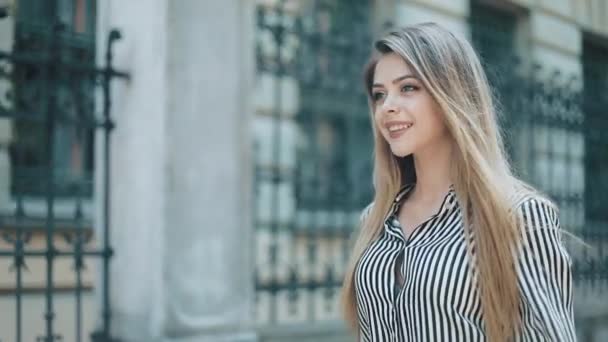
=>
[518,199,576,342]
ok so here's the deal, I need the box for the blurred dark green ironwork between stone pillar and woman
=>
[255,0,372,322]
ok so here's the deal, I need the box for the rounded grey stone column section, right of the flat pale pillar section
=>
[164,0,255,341]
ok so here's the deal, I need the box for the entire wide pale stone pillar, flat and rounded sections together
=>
[97,0,256,341]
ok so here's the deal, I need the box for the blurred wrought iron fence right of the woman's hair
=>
[493,59,608,285]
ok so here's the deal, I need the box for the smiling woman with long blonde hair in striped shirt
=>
[342,23,576,341]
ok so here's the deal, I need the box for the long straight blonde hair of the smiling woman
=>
[341,23,534,341]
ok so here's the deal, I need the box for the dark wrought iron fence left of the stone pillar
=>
[0,10,128,342]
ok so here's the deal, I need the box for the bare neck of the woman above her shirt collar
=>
[412,139,453,202]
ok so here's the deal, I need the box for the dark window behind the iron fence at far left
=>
[10,0,96,197]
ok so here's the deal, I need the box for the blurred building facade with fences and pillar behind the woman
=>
[0,0,608,342]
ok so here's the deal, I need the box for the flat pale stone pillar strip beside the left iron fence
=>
[95,0,169,341]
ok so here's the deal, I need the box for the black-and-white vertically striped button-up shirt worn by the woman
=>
[355,186,576,342]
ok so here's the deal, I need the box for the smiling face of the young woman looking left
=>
[371,53,448,157]
